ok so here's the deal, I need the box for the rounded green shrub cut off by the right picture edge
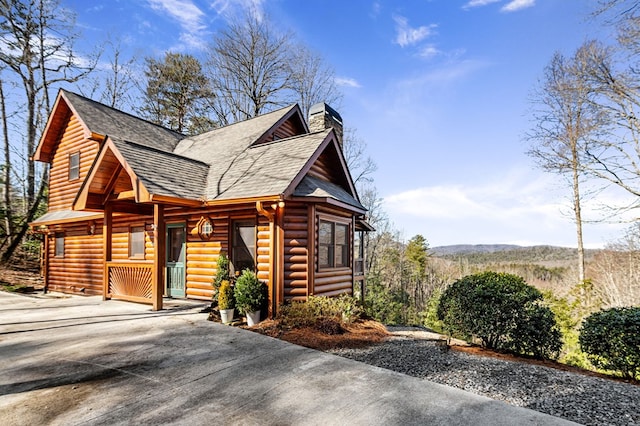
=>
[578,307,640,379]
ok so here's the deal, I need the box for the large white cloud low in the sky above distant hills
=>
[384,169,624,247]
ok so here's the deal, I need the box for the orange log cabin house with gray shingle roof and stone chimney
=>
[31,90,371,312]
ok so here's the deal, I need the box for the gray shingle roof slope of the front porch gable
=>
[111,138,209,200]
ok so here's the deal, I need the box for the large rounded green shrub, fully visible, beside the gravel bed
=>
[438,272,562,358]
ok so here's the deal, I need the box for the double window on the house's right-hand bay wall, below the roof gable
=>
[318,220,349,269]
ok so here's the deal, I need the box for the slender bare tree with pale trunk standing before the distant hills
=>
[528,42,606,281]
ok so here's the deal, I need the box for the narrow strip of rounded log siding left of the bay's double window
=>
[284,204,309,300]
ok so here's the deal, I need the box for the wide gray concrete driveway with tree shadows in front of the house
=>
[0,292,570,426]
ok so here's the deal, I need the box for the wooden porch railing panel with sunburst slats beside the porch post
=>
[105,261,153,304]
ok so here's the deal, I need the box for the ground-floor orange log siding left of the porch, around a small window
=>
[47,221,103,295]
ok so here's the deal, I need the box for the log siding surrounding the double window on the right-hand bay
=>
[313,207,353,297]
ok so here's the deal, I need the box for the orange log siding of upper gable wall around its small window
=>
[48,115,99,211]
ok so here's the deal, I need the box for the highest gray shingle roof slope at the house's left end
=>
[62,90,184,151]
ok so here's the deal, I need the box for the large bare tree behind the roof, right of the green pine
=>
[207,16,292,125]
